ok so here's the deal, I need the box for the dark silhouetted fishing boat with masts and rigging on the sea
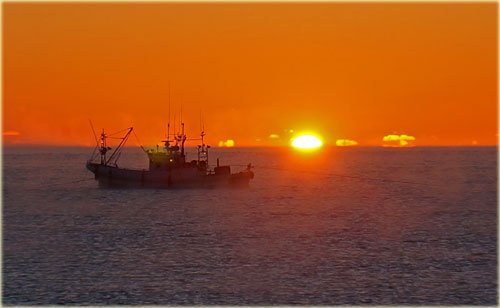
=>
[86,123,254,188]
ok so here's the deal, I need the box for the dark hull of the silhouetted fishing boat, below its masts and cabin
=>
[87,162,254,188]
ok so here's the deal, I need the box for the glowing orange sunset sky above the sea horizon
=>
[3,3,498,145]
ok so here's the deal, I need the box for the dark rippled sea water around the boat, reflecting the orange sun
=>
[2,147,498,305]
